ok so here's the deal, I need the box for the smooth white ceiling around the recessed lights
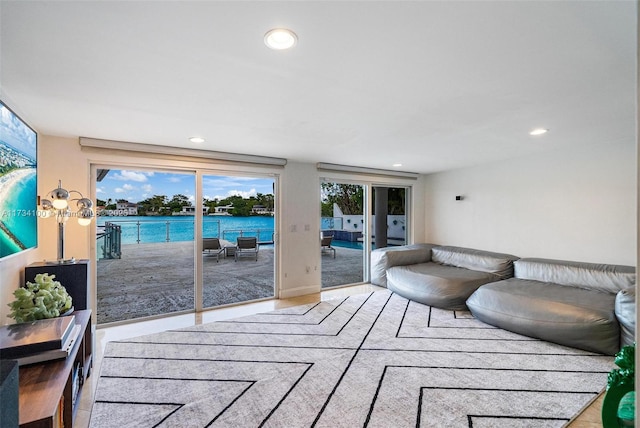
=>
[0,0,637,173]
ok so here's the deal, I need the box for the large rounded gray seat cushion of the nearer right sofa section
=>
[467,278,620,355]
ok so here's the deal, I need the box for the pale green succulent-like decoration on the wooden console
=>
[9,273,72,323]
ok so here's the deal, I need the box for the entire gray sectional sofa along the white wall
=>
[371,244,636,355]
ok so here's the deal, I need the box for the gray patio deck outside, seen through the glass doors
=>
[97,242,363,324]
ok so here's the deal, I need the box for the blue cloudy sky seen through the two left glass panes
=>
[96,169,273,202]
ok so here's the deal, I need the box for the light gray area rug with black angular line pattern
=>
[91,291,613,428]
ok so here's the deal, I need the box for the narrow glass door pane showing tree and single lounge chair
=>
[320,182,366,288]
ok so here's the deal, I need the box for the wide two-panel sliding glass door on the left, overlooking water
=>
[93,166,275,324]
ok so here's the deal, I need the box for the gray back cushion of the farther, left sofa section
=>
[431,246,518,279]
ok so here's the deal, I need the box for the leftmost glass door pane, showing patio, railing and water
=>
[96,169,195,324]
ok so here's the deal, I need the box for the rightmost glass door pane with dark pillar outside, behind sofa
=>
[371,186,408,248]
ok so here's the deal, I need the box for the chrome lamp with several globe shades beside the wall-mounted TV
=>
[40,180,93,263]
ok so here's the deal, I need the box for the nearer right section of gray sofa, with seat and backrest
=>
[467,259,636,355]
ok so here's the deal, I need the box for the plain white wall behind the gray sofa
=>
[425,142,637,266]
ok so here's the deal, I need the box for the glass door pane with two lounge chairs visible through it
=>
[202,175,275,308]
